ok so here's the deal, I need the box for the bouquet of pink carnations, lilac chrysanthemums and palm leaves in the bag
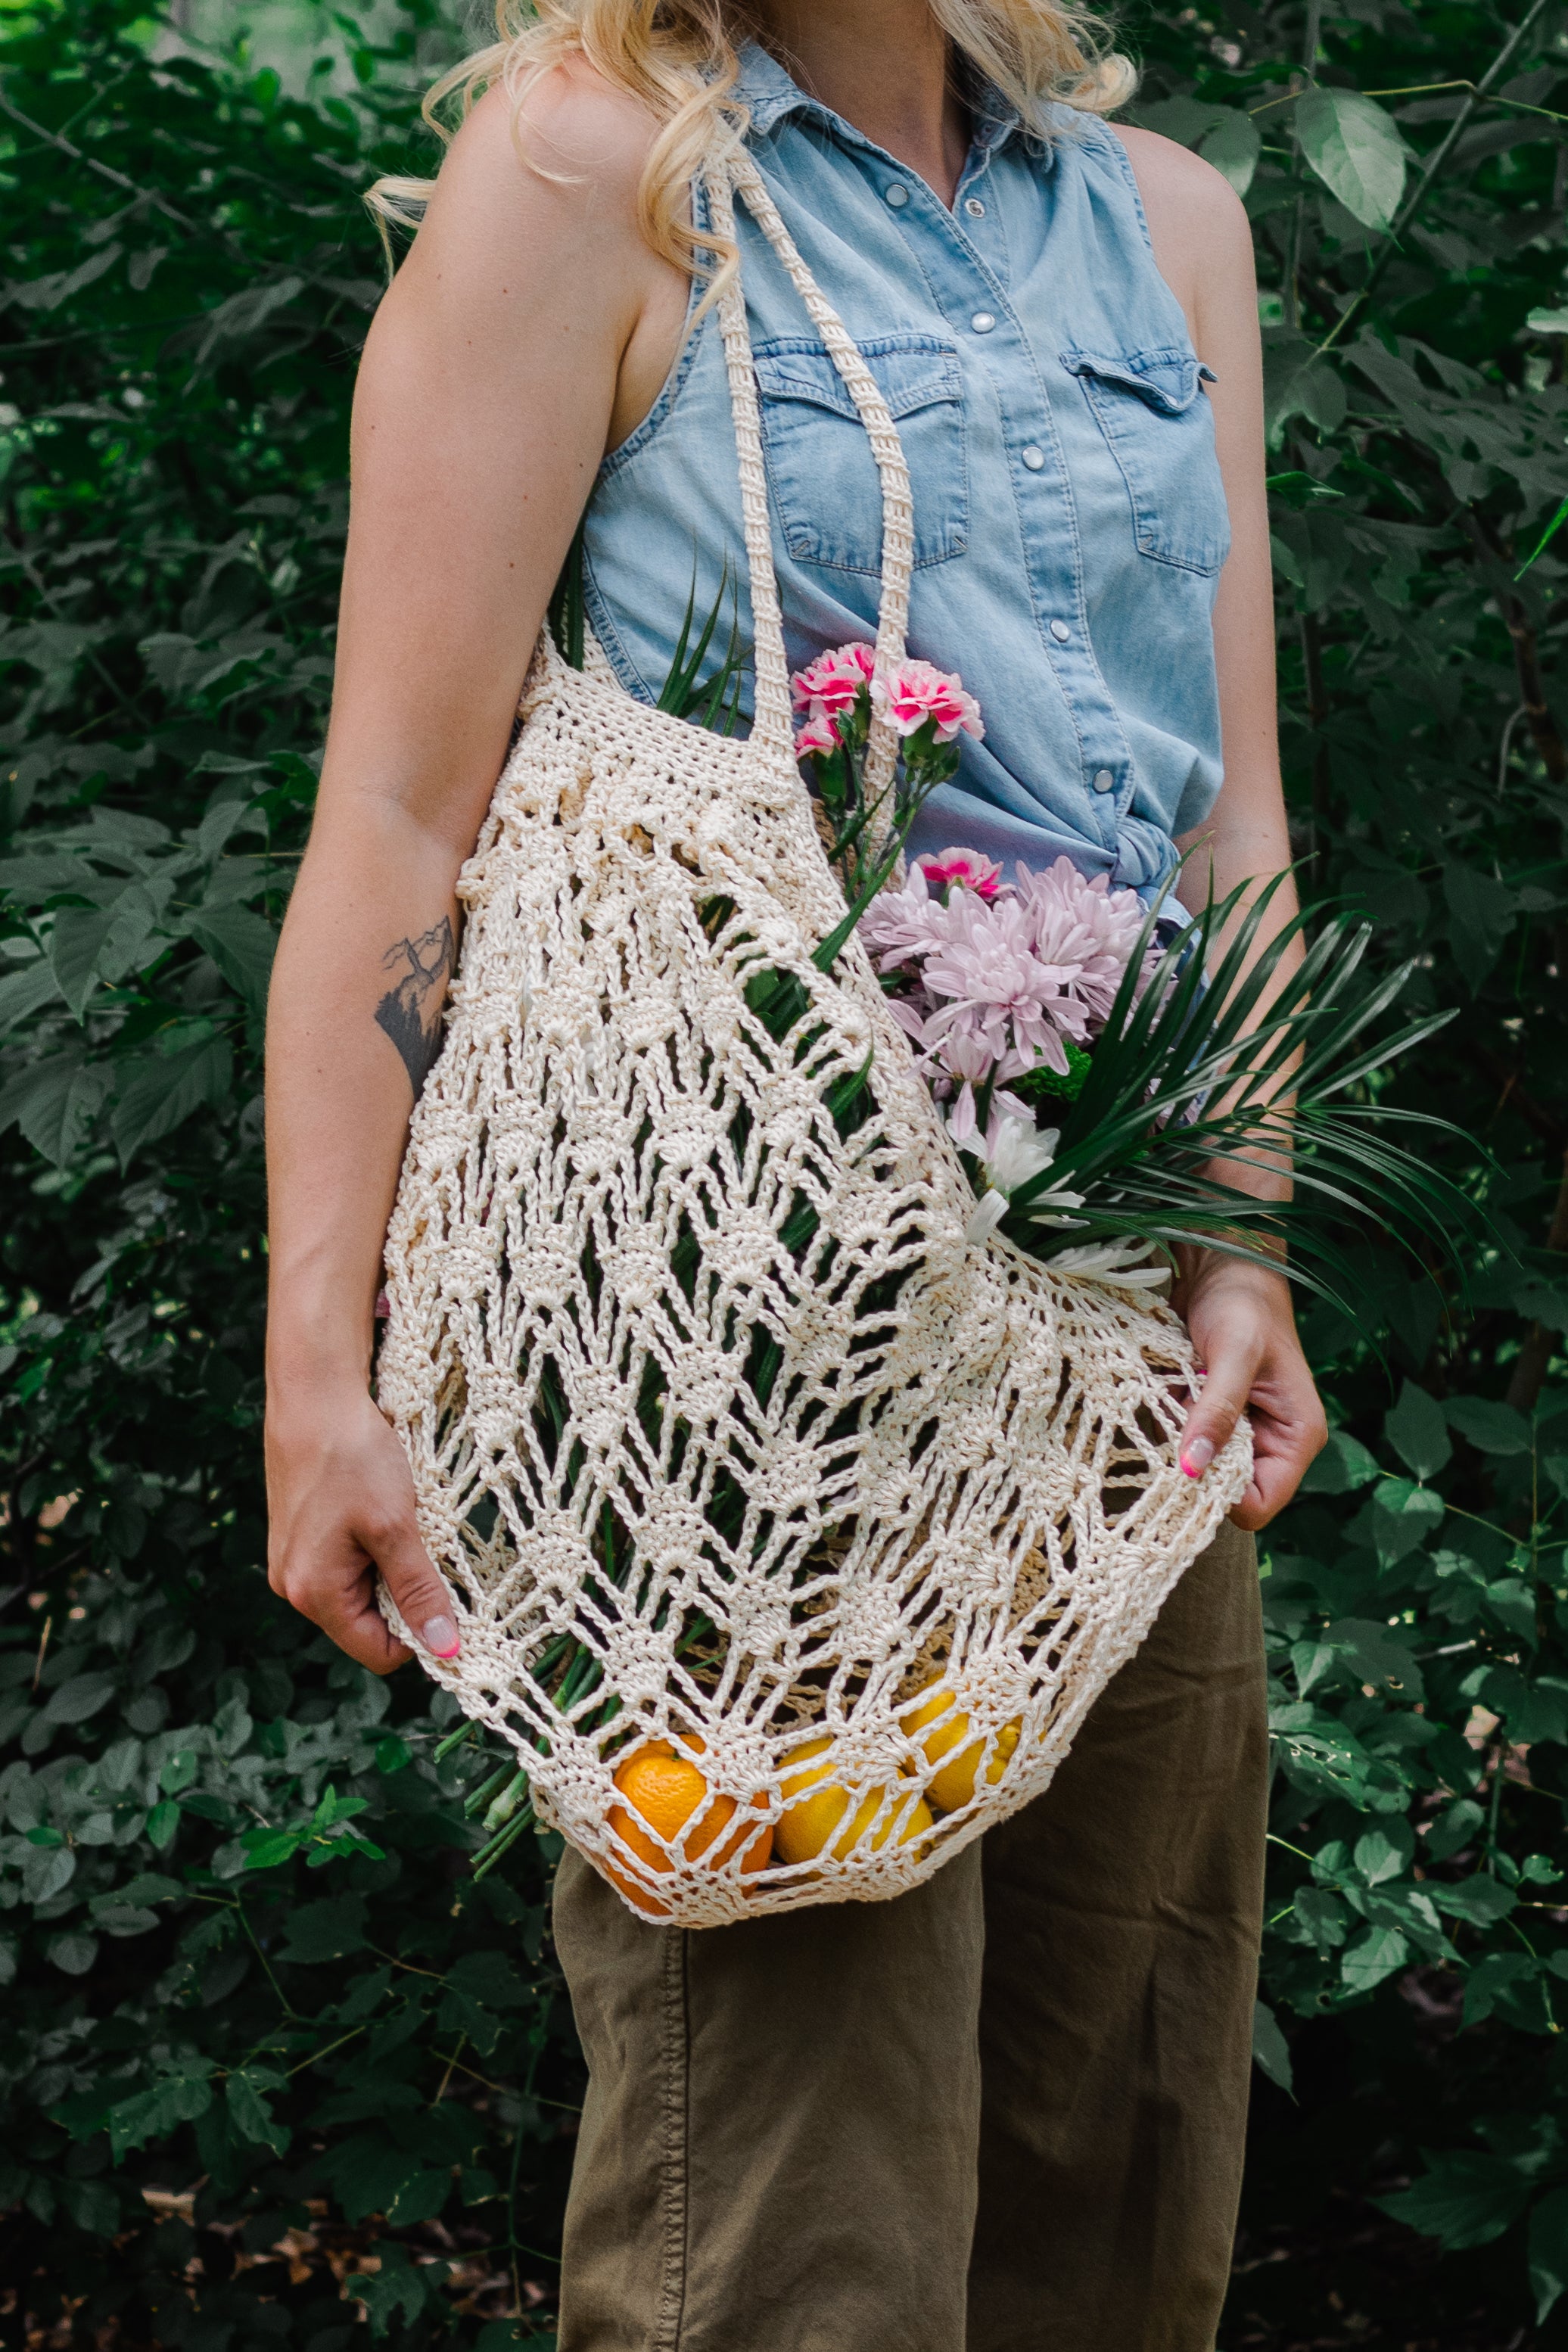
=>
[795,645,1474,1303]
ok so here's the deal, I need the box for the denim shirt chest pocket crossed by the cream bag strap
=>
[754,334,969,576]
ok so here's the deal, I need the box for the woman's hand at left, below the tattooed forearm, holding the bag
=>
[266,1383,461,1675]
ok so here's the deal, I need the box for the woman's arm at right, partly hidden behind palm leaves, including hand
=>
[1122,129,1328,1526]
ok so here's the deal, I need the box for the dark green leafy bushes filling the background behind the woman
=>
[0,0,1568,2352]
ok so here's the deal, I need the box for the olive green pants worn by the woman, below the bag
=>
[555,1526,1267,2352]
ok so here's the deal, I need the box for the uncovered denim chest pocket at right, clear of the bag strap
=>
[1062,348,1230,585]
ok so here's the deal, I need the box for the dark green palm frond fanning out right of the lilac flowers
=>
[999,875,1498,1322]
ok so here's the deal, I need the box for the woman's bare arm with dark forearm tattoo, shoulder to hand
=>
[268,70,686,1672]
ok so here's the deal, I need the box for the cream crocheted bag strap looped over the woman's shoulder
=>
[705,141,914,835]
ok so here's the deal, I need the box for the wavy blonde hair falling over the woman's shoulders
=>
[367,0,1135,285]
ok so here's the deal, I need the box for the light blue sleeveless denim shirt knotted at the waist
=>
[583,45,1230,903]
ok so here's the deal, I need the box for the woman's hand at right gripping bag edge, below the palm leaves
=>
[1173,1249,1328,1529]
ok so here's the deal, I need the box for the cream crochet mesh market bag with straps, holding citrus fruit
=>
[378,148,1251,1926]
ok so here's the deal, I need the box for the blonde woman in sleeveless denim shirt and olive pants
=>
[268,0,1324,2352]
